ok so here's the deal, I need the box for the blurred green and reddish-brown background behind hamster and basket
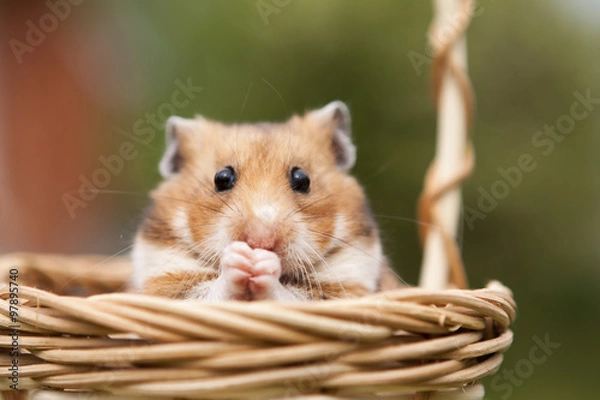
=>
[1,0,600,400]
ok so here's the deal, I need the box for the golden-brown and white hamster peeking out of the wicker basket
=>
[132,101,401,301]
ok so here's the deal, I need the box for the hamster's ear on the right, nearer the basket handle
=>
[308,100,356,171]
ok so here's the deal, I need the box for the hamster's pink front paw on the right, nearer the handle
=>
[248,249,283,300]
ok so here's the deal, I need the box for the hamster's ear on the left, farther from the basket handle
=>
[158,116,205,179]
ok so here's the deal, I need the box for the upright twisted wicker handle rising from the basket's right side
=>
[419,0,474,289]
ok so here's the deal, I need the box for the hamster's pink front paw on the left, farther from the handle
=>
[219,242,254,300]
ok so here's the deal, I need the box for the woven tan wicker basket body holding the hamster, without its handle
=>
[0,254,515,399]
